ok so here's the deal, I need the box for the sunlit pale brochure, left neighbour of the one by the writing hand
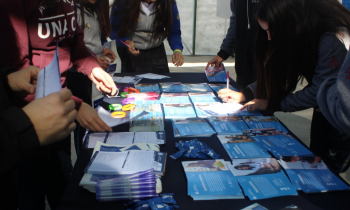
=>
[163,103,197,119]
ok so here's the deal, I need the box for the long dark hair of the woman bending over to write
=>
[254,0,350,110]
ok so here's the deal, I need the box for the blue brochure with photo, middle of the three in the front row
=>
[227,158,298,200]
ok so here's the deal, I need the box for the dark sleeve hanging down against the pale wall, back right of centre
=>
[218,0,236,60]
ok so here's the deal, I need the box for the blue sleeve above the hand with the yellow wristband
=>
[167,4,183,51]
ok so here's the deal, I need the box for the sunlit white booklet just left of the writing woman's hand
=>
[194,102,230,117]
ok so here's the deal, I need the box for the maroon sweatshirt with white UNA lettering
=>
[0,0,100,108]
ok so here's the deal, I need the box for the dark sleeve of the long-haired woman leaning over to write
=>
[281,33,347,112]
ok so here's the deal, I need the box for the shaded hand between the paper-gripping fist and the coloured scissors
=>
[77,102,112,132]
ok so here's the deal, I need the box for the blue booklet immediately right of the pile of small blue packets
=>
[218,135,271,159]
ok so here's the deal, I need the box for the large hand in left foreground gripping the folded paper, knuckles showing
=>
[23,89,77,146]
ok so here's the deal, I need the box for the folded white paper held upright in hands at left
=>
[35,45,61,99]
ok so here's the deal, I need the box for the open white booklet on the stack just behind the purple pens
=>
[85,151,166,175]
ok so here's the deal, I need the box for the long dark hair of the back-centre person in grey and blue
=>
[114,0,176,42]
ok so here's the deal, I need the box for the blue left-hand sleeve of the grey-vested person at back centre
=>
[109,3,128,47]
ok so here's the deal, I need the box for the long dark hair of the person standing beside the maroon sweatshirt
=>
[79,0,112,38]
